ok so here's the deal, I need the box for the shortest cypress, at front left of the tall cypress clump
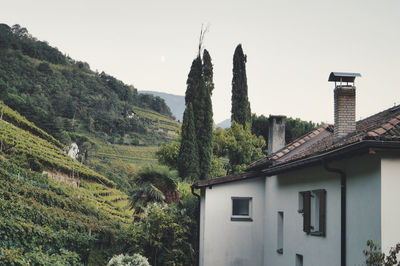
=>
[178,102,199,180]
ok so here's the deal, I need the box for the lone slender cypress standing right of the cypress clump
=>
[231,44,251,127]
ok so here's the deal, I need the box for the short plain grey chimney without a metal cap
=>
[268,115,286,154]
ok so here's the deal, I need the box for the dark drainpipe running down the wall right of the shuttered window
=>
[322,161,347,266]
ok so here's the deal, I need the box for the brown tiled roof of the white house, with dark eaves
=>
[193,105,400,187]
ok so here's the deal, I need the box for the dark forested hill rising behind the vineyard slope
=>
[0,24,179,144]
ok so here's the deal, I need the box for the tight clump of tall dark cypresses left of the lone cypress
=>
[178,50,214,179]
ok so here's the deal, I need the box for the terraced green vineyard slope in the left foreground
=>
[0,103,133,265]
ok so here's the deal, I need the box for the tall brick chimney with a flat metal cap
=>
[329,72,361,142]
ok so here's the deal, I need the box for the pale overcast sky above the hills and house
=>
[0,0,400,123]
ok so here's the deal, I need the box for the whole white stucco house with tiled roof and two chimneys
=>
[193,73,400,266]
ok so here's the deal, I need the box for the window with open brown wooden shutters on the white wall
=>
[298,189,326,236]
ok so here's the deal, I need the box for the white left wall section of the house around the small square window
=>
[200,177,265,266]
